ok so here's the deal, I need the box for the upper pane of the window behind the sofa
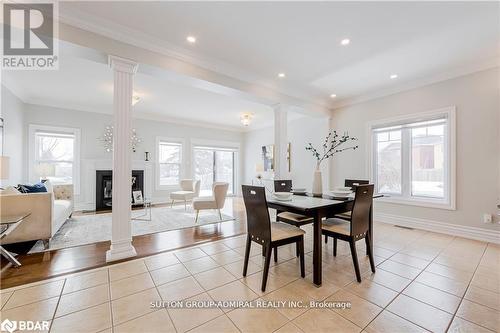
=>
[36,135,74,161]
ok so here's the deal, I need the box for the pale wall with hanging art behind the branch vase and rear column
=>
[244,115,329,190]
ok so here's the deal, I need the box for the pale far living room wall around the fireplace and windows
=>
[24,104,243,207]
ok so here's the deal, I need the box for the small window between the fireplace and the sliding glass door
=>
[158,140,182,187]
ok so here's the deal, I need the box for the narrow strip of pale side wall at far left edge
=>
[0,85,26,187]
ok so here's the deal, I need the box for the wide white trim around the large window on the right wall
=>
[366,106,456,210]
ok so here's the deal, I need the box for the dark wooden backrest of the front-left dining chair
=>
[241,185,271,245]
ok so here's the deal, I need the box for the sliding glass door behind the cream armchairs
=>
[193,147,236,195]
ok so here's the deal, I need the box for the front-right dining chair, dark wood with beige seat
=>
[321,184,375,282]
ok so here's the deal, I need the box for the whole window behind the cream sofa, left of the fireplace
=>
[30,125,80,194]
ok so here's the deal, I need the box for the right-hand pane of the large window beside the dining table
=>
[411,125,444,198]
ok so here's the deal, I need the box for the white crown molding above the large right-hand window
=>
[330,57,500,111]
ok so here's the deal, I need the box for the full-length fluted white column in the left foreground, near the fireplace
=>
[106,56,137,262]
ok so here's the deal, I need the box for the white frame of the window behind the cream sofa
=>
[28,124,81,195]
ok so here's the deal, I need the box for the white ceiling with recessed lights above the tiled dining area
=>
[60,1,500,107]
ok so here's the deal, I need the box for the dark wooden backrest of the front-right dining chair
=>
[351,184,373,236]
